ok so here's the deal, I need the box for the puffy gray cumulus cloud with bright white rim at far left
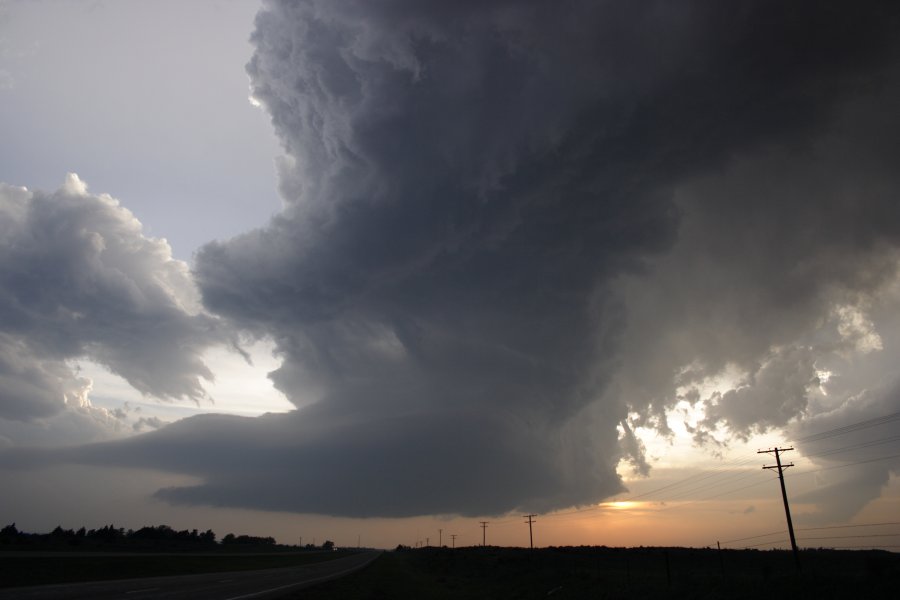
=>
[0,175,220,421]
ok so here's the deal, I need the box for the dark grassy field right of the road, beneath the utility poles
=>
[287,548,900,600]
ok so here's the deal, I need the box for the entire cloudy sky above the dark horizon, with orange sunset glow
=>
[0,0,900,549]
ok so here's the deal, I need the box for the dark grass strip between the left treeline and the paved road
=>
[0,552,353,587]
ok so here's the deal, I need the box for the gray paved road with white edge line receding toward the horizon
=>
[0,551,381,600]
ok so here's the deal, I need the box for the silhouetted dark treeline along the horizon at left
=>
[0,523,334,551]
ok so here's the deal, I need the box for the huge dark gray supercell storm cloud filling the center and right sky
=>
[1,0,900,516]
